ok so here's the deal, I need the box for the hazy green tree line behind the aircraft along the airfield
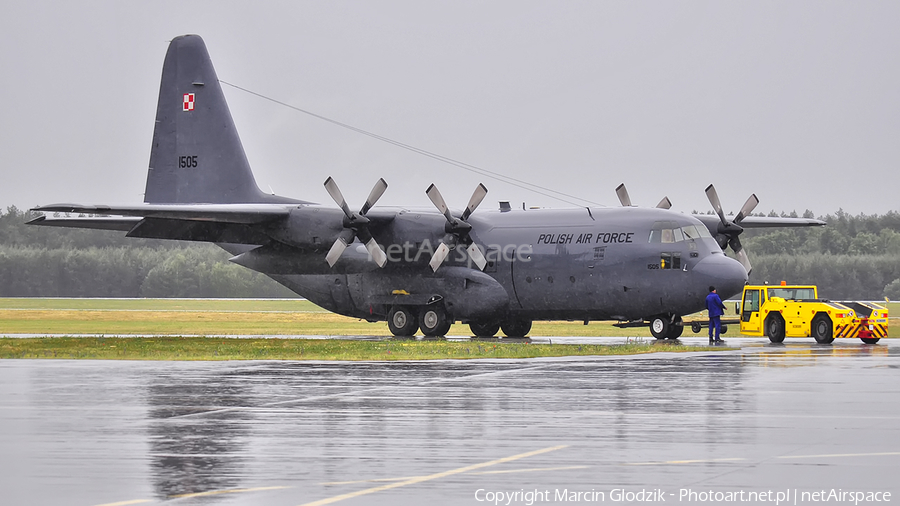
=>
[0,207,900,300]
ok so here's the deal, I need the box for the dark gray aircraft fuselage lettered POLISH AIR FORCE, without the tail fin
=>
[241,206,747,321]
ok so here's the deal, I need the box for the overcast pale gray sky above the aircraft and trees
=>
[0,0,900,215]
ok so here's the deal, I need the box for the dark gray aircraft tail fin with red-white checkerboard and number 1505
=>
[144,35,294,204]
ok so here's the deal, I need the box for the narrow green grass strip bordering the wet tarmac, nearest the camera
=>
[0,336,721,361]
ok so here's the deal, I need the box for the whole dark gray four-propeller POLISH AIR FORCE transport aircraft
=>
[29,35,824,339]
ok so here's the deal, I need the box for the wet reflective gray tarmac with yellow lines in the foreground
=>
[0,337,900,506]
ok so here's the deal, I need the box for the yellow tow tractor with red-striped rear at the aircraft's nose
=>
[740,281,888,344]
